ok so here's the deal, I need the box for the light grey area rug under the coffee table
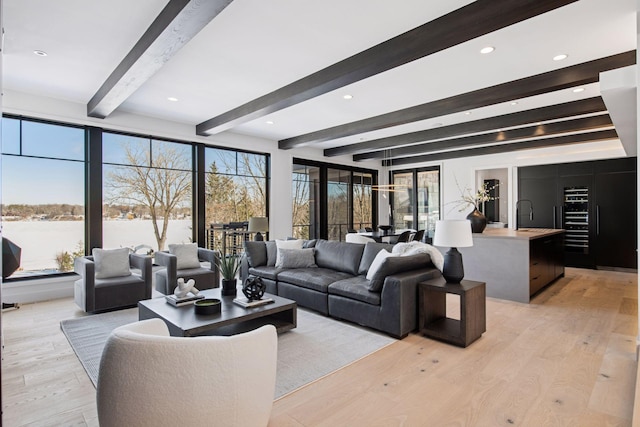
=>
[60,308,395,398]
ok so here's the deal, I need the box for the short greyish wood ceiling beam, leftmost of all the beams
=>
[87,0,233,119]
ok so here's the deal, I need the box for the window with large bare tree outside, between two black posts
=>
[102,132,193,251]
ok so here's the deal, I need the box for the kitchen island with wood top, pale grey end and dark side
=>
[456,228,564,303]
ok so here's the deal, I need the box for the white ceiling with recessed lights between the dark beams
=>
[3,0,637,159]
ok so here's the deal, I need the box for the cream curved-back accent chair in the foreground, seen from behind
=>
[96,319,278,427]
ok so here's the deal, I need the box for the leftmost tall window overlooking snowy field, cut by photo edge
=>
[2,117,85,278]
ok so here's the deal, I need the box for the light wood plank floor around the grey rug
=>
[2,269,638,427]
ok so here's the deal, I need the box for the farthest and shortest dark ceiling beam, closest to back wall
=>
[382,129,618,166]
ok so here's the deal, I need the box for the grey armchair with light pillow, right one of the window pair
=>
[155,243,220,295]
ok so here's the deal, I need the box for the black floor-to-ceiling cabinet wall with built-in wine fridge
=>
[518,157,638,269]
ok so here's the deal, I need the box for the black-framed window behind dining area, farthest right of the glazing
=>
[391,167,440,238]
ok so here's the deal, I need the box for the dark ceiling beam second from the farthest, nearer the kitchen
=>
[353,114,613,161]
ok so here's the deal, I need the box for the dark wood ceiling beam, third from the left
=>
[278,50,636,149]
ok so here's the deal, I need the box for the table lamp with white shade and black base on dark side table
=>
[433,219,473,283]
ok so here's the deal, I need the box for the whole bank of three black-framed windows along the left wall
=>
[1,116,269,280]
